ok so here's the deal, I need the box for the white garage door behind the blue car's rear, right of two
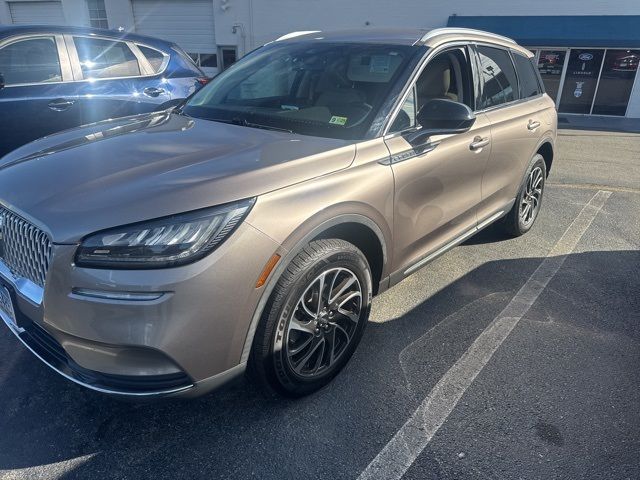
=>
[132,0,216,61]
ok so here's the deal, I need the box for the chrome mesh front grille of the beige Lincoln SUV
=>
[0,207,51,287]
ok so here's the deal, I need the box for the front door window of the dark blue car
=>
[0,37,62,85]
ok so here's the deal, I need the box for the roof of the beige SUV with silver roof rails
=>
[276,28,531,56]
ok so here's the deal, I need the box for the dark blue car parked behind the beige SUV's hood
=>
[0,25,207,156]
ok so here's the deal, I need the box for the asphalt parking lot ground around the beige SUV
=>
[0,130,640,480]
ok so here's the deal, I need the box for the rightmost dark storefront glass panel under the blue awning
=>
[592,50,640,116]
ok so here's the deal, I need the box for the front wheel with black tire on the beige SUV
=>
[249,239,372,397]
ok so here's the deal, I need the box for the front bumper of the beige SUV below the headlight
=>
[0,223,279,398]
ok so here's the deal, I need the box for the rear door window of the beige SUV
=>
[478,47,518,109]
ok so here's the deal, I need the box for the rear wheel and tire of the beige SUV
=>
[502,154,547,237]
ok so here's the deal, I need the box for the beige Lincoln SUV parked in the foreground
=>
[0,28,557,398]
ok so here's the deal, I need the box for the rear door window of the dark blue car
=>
[73,37,140,78]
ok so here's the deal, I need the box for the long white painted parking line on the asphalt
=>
[358,190,611,480]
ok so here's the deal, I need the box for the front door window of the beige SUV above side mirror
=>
[390,48,474,133]
